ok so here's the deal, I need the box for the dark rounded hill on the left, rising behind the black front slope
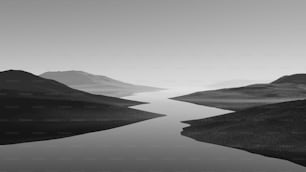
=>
[0,70,142,107]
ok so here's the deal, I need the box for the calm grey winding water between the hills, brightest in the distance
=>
[0,91,306,172]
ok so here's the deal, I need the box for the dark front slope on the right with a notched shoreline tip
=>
[182,100,306,166]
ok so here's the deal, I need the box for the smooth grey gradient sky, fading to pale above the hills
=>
[0,0,306,88]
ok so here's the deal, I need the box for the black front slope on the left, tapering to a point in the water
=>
[0,98,162,145]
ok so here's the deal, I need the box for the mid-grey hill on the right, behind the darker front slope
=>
[173,74,306,111]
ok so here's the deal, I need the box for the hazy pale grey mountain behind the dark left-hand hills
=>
[40,71,161,97]
